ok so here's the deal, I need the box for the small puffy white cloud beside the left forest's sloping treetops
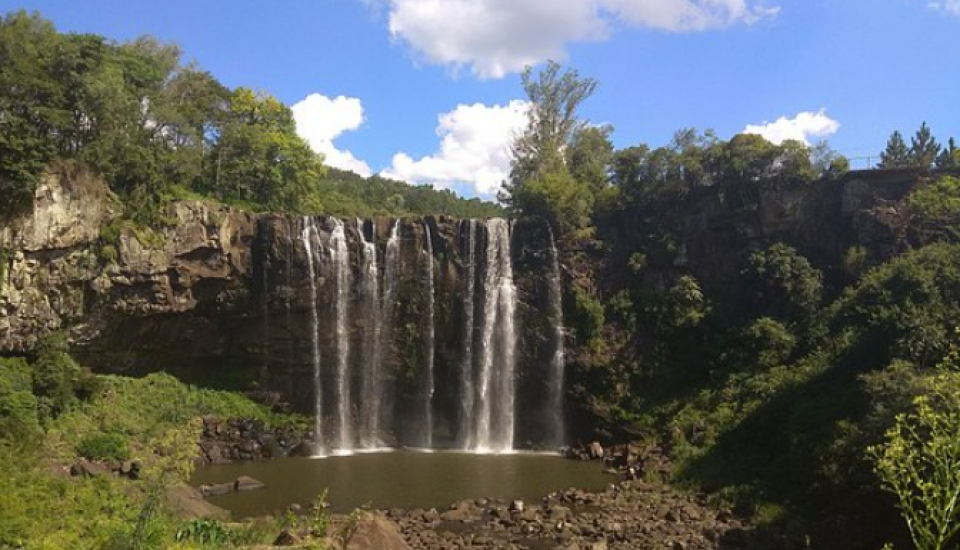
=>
[290,93,372,177]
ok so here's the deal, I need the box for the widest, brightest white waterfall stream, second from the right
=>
[474,218,517,458]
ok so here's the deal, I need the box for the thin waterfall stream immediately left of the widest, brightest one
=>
[457,220,477,449]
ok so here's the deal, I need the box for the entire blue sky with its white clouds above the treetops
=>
[0,0,960,196]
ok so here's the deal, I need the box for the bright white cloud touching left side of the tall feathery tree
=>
[382,100,528,197]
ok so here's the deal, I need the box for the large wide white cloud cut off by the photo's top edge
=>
[385,0,780,78]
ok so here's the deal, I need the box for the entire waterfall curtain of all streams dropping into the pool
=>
[286,217,565,456]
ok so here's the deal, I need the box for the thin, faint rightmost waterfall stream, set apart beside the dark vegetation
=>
[547,229,566,449]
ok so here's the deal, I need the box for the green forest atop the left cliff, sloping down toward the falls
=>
[0,11,501,222]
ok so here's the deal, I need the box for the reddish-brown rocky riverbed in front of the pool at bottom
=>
[387,481,782,550]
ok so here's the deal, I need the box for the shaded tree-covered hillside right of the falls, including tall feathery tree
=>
[504,64,960,548]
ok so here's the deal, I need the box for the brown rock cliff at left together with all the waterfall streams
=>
[0,170,562,451]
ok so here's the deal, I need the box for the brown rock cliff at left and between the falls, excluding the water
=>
[0,167,554,448]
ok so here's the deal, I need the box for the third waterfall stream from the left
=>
[357,218,382,449]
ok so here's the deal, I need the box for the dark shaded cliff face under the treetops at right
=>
[601,170,923,306]
